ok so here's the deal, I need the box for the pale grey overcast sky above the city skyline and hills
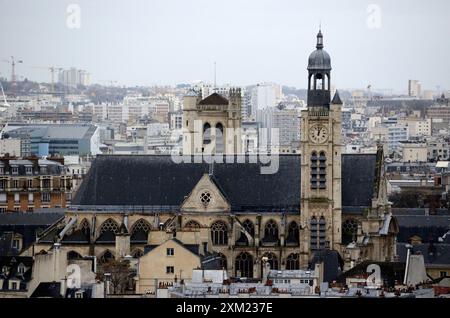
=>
[0,0,450,91]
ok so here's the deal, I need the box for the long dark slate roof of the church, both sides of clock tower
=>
[72,154,376,213]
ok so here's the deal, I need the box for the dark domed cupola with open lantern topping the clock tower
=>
[308,30,331,107]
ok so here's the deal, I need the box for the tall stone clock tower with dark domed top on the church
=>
[300,31,342,267]
